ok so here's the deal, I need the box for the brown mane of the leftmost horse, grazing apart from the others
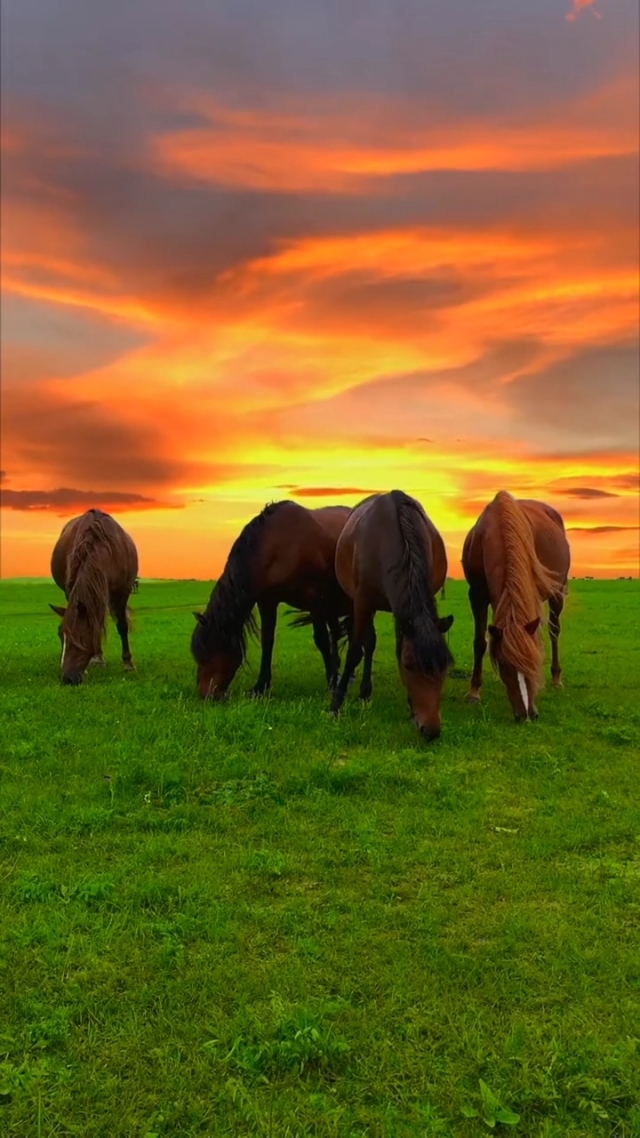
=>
[66,510,114,651]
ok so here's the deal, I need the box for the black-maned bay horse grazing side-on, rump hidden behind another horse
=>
[191,501,351,700]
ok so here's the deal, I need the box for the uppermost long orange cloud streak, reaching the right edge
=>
[149,77,638,193]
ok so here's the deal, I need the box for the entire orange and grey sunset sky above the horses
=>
[0,0,640,578]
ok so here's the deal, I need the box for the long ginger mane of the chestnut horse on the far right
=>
[490,490,559,691]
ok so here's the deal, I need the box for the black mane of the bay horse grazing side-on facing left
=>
[191,500,289,663]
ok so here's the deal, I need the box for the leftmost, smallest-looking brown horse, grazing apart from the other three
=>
[49,510,138,684]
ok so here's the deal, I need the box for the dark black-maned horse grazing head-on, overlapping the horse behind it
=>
[333,490,453,739]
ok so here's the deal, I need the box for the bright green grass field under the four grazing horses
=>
[0,582,640,1138]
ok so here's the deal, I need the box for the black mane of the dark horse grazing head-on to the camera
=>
[391,490,453,676]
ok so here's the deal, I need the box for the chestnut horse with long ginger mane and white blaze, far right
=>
[462,490,571,721]
